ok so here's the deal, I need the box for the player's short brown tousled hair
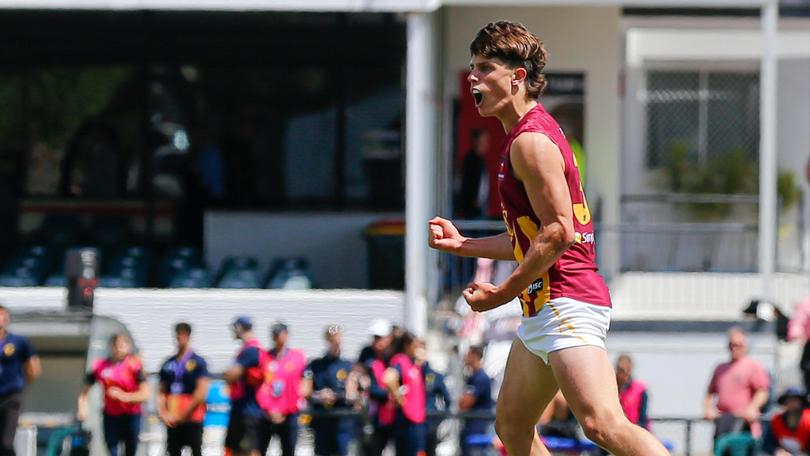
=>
[470,21,548,98]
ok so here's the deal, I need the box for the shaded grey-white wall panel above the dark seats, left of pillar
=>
[205,212,400,288]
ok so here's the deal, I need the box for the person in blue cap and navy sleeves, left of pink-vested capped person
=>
[222,316,266,456]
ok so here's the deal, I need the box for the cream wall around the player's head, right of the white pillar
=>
[444,6,621,273]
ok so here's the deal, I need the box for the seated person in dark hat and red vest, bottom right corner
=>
[770,387,810,456]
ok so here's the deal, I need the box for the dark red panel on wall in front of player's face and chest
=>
[456,70,506,217]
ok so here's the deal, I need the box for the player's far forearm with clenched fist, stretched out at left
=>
[428,217,508,261]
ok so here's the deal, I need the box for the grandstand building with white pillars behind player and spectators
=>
[0,0,810,454]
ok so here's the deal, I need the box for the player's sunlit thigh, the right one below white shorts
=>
[549,345,624,423]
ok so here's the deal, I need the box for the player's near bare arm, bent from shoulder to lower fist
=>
[463,133,574,312]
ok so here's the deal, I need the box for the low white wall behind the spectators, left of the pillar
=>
[0,288,405,372]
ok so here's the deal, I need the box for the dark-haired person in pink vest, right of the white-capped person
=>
[383,331,427,456]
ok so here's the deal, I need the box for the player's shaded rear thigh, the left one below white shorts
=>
[496,339,557,426]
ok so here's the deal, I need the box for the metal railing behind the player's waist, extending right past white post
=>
[440,193,810,295]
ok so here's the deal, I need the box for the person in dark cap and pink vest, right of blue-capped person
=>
[256,322,307,456]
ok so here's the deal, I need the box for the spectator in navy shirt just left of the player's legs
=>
[458,345,494,455]
